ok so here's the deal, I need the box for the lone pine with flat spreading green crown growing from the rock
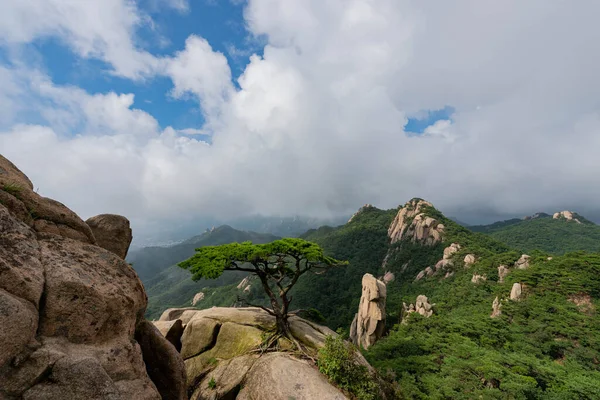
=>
[178,238,347,339]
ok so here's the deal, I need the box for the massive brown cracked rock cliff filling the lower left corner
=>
[0,156,185,400]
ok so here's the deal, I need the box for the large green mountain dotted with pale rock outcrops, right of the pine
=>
[180,199,600,399]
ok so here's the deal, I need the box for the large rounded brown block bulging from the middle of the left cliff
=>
[39,236,146,343]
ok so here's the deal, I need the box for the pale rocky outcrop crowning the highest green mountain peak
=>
[388,199,444,245]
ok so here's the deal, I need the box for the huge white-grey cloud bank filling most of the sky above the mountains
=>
[5,0,600,239]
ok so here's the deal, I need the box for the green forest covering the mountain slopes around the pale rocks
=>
[134,207,600,399]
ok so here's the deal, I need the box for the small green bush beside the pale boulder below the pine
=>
[317,336,378,400]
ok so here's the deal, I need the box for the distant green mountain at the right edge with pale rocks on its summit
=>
[468,211,600,254]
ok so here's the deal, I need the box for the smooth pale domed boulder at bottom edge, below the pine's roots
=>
[236,353,347,400]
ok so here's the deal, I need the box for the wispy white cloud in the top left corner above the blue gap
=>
[0,0,160,79]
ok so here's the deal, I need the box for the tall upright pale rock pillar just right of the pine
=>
[350,274,387,349]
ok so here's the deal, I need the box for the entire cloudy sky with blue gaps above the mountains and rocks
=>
[0,0,600,241]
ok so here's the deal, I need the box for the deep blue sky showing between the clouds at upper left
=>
[31,0,262,129]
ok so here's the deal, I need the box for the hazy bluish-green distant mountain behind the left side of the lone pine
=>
[127,225,278,319]
